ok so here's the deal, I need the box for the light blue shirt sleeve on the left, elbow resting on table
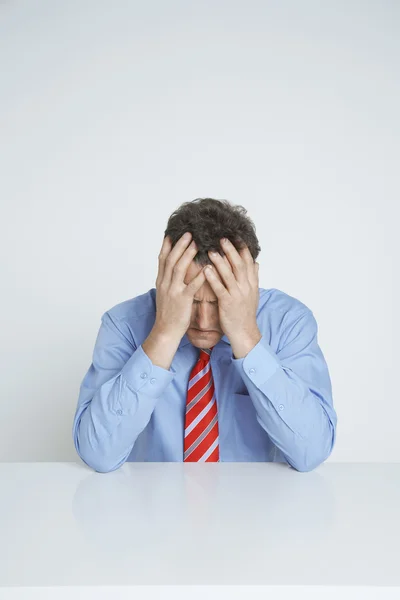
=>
[72,312,175,472]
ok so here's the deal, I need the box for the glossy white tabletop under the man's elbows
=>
[0,463,400,600]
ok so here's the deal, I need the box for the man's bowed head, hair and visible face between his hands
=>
[164,198,261,348]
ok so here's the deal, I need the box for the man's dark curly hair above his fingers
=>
[164,198,261,267]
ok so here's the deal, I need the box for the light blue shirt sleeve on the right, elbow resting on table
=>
[232,310,337,471]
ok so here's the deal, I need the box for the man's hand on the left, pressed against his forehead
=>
[154,233,206,340]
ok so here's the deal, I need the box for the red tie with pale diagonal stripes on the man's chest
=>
[183,346,219,462]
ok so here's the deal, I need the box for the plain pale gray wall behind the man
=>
[0,0,400,461]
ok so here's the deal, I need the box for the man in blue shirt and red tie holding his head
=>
[73,198,337,472]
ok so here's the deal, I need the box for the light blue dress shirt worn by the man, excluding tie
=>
[72,288,337,472]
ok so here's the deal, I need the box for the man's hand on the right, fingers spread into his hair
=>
[204,240,259,340]
